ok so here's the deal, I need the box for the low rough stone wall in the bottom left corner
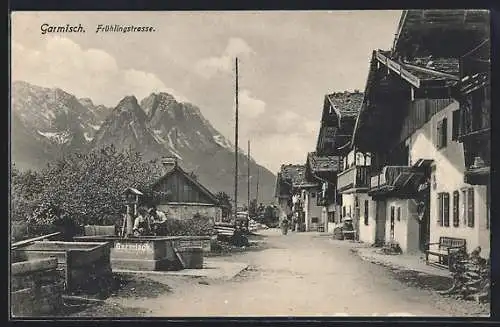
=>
[10,258,63,317]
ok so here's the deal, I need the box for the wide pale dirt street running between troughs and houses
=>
[104,230,488,317]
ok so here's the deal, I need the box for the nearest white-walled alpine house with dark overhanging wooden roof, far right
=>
[351,10,490,256]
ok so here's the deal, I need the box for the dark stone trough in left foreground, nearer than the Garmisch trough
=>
[11,241,112,293]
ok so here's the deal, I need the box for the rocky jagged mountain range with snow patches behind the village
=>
[11,81,275,203]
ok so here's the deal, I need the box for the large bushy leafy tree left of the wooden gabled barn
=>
[23,146,161,232]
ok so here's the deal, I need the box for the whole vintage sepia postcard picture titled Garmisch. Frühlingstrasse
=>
[9,9,490,319]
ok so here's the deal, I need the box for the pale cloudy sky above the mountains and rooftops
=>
[11,10,401,172]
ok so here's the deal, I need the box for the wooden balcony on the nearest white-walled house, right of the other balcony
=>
[368,166,424,198]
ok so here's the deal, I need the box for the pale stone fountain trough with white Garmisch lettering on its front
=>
[74,235,211,271]
